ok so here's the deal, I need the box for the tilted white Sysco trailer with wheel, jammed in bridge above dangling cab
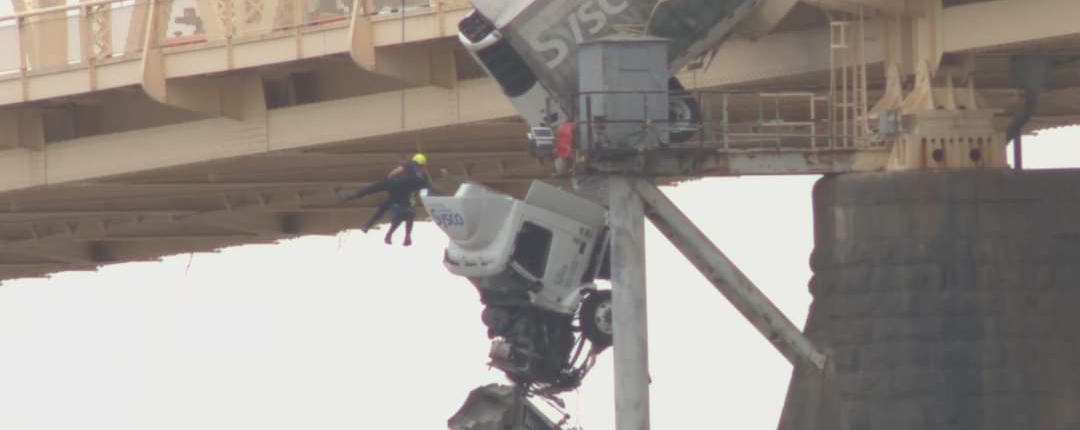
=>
[458,0,761,146]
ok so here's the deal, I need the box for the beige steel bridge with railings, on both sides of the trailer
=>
[0,0,1080,280]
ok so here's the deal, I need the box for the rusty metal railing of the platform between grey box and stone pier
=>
[570,91,875,151]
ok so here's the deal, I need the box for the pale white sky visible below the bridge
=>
[0,129,1080,430]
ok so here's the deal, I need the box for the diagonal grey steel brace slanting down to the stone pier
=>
[634,180,826,371]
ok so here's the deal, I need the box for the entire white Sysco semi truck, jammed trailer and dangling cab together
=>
[438,0,764,430]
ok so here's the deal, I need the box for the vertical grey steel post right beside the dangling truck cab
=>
[608,176,649,430]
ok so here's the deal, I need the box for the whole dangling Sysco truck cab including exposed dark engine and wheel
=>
[422,182,612,392]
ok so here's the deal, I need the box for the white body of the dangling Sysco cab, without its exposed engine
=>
[423,180,608,314]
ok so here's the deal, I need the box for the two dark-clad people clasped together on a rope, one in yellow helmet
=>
[337,152,431,236]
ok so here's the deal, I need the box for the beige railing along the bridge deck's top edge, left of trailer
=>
[0,0,469,80]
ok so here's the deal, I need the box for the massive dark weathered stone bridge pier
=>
[779,170,1080,430]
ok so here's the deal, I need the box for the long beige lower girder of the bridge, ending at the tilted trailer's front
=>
[0,79,515,192]
